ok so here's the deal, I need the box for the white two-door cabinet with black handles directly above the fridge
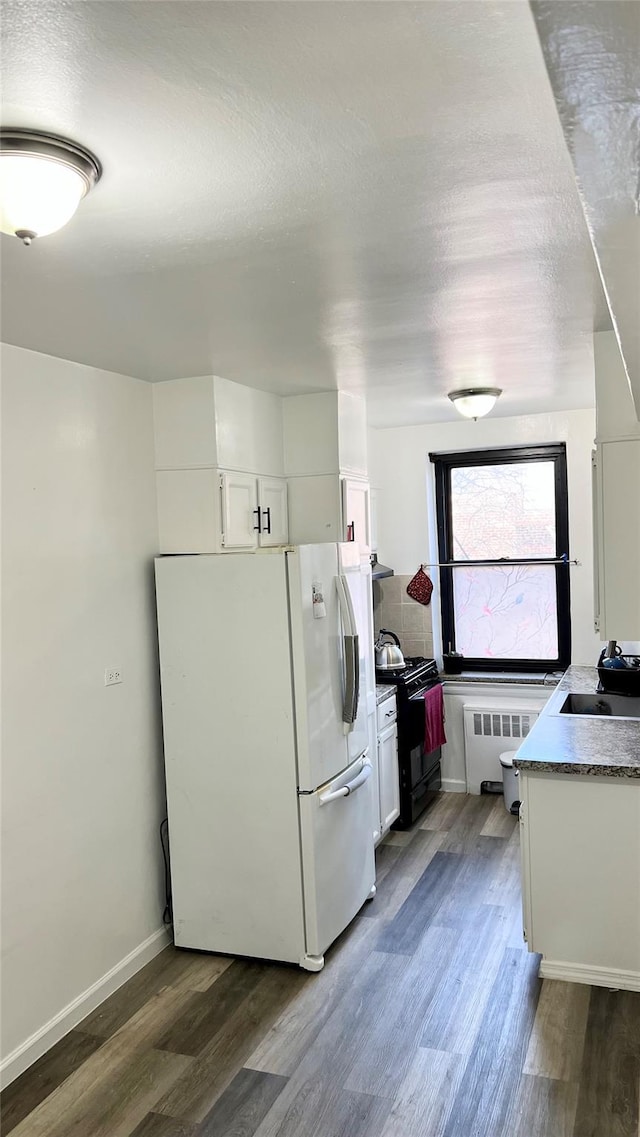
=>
[156,461,289,553]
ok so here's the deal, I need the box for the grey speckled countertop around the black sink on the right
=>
[514,667,640,778]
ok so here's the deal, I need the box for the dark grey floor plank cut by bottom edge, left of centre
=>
[198,1069,286,1137]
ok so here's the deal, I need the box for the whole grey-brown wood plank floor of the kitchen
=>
[2,794,640,1137]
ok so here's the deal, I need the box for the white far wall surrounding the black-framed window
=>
[369,409,600,664]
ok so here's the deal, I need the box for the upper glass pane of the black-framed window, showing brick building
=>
[451,462,556,554]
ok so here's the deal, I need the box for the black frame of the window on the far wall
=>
[429,442,571,672]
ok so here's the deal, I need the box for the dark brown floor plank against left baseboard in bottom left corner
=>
[0,1030,102,1135]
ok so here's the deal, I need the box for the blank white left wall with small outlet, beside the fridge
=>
[1,346,164,1076]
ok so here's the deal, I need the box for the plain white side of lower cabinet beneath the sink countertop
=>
[520,770,640,990]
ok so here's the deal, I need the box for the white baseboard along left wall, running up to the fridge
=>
[0,928,169,1089]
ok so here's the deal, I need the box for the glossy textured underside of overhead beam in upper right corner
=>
[532,0,640,417]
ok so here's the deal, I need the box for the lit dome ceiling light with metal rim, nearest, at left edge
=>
[0,128,102,244]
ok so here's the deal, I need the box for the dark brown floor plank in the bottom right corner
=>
[573,987,640,1137]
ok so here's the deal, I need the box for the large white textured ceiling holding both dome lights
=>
[1,0,609,425]
